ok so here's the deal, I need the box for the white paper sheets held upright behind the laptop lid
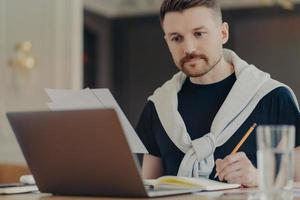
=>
[45,88,148,153]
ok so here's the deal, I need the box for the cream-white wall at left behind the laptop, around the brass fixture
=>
[0,0,83,164]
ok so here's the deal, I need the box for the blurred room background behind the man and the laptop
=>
[0,0,300,182]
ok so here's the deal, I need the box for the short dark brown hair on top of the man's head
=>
[160,0,222,23]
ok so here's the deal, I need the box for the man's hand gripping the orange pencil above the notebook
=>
[216,152,259,187]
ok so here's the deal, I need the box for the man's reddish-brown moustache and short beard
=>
[180,53,223,78]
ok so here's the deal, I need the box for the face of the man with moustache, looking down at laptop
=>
[163,6,228,77]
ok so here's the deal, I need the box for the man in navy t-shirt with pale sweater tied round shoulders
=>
[136,0,300,187]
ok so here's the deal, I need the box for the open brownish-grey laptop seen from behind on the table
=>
[7,109,202,197]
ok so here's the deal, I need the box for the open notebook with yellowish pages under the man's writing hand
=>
[144,176,241,191]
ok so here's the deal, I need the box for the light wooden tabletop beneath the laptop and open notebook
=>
[0,189,300,200]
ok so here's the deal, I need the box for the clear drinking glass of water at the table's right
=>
[256,125,295,200]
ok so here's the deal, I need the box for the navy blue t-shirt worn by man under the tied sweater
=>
[136,73,300,178]
